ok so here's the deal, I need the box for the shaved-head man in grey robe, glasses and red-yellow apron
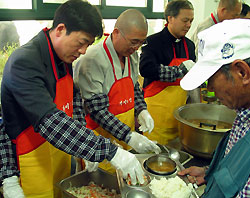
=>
[74,9,160,171]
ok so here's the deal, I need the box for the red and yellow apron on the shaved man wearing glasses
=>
[86,37,135,172]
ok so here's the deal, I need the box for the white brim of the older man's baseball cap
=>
[180,61,221,91]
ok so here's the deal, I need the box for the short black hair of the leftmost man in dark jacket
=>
[52,0,103,38]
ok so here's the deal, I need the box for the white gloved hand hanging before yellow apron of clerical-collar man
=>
[138,110,154,133]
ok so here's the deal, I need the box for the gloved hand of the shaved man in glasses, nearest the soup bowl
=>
[128,132,161,154]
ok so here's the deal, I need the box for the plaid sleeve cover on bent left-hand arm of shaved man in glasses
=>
[84,94,130,140]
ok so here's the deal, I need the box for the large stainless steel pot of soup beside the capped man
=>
[174,103,236,158]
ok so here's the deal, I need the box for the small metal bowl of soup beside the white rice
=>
[143,154,176,175]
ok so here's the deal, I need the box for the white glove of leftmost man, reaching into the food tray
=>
[110,147,145,185]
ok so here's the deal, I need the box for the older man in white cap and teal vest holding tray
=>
[179,19,250,198]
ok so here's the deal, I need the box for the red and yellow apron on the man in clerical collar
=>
[143,39,189,145]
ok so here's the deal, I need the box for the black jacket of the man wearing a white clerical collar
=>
[140,27,196,87]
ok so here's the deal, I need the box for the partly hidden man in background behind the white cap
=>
[191,0,242,58]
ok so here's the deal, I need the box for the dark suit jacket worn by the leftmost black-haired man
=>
[1,31,72,139]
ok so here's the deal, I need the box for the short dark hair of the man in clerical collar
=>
[164,0,194,21]
